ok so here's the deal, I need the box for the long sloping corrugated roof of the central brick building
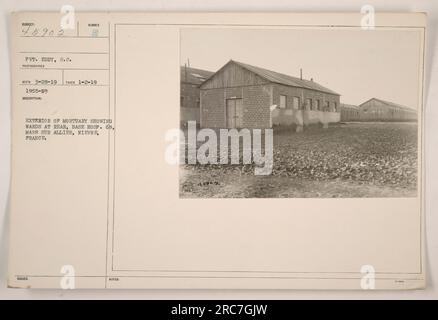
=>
[230,60,340,95]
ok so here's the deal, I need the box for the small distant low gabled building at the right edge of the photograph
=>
[359,98,417,121]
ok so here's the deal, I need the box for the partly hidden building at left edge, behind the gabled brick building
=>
[180,66,213,123]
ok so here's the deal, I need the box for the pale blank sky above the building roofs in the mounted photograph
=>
[181,28,421,108]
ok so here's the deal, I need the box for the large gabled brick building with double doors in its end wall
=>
[200,60,340,130]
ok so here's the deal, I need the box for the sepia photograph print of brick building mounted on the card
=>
[179,27,422,198]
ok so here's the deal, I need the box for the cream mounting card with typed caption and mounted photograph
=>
[8,11,426,289]
